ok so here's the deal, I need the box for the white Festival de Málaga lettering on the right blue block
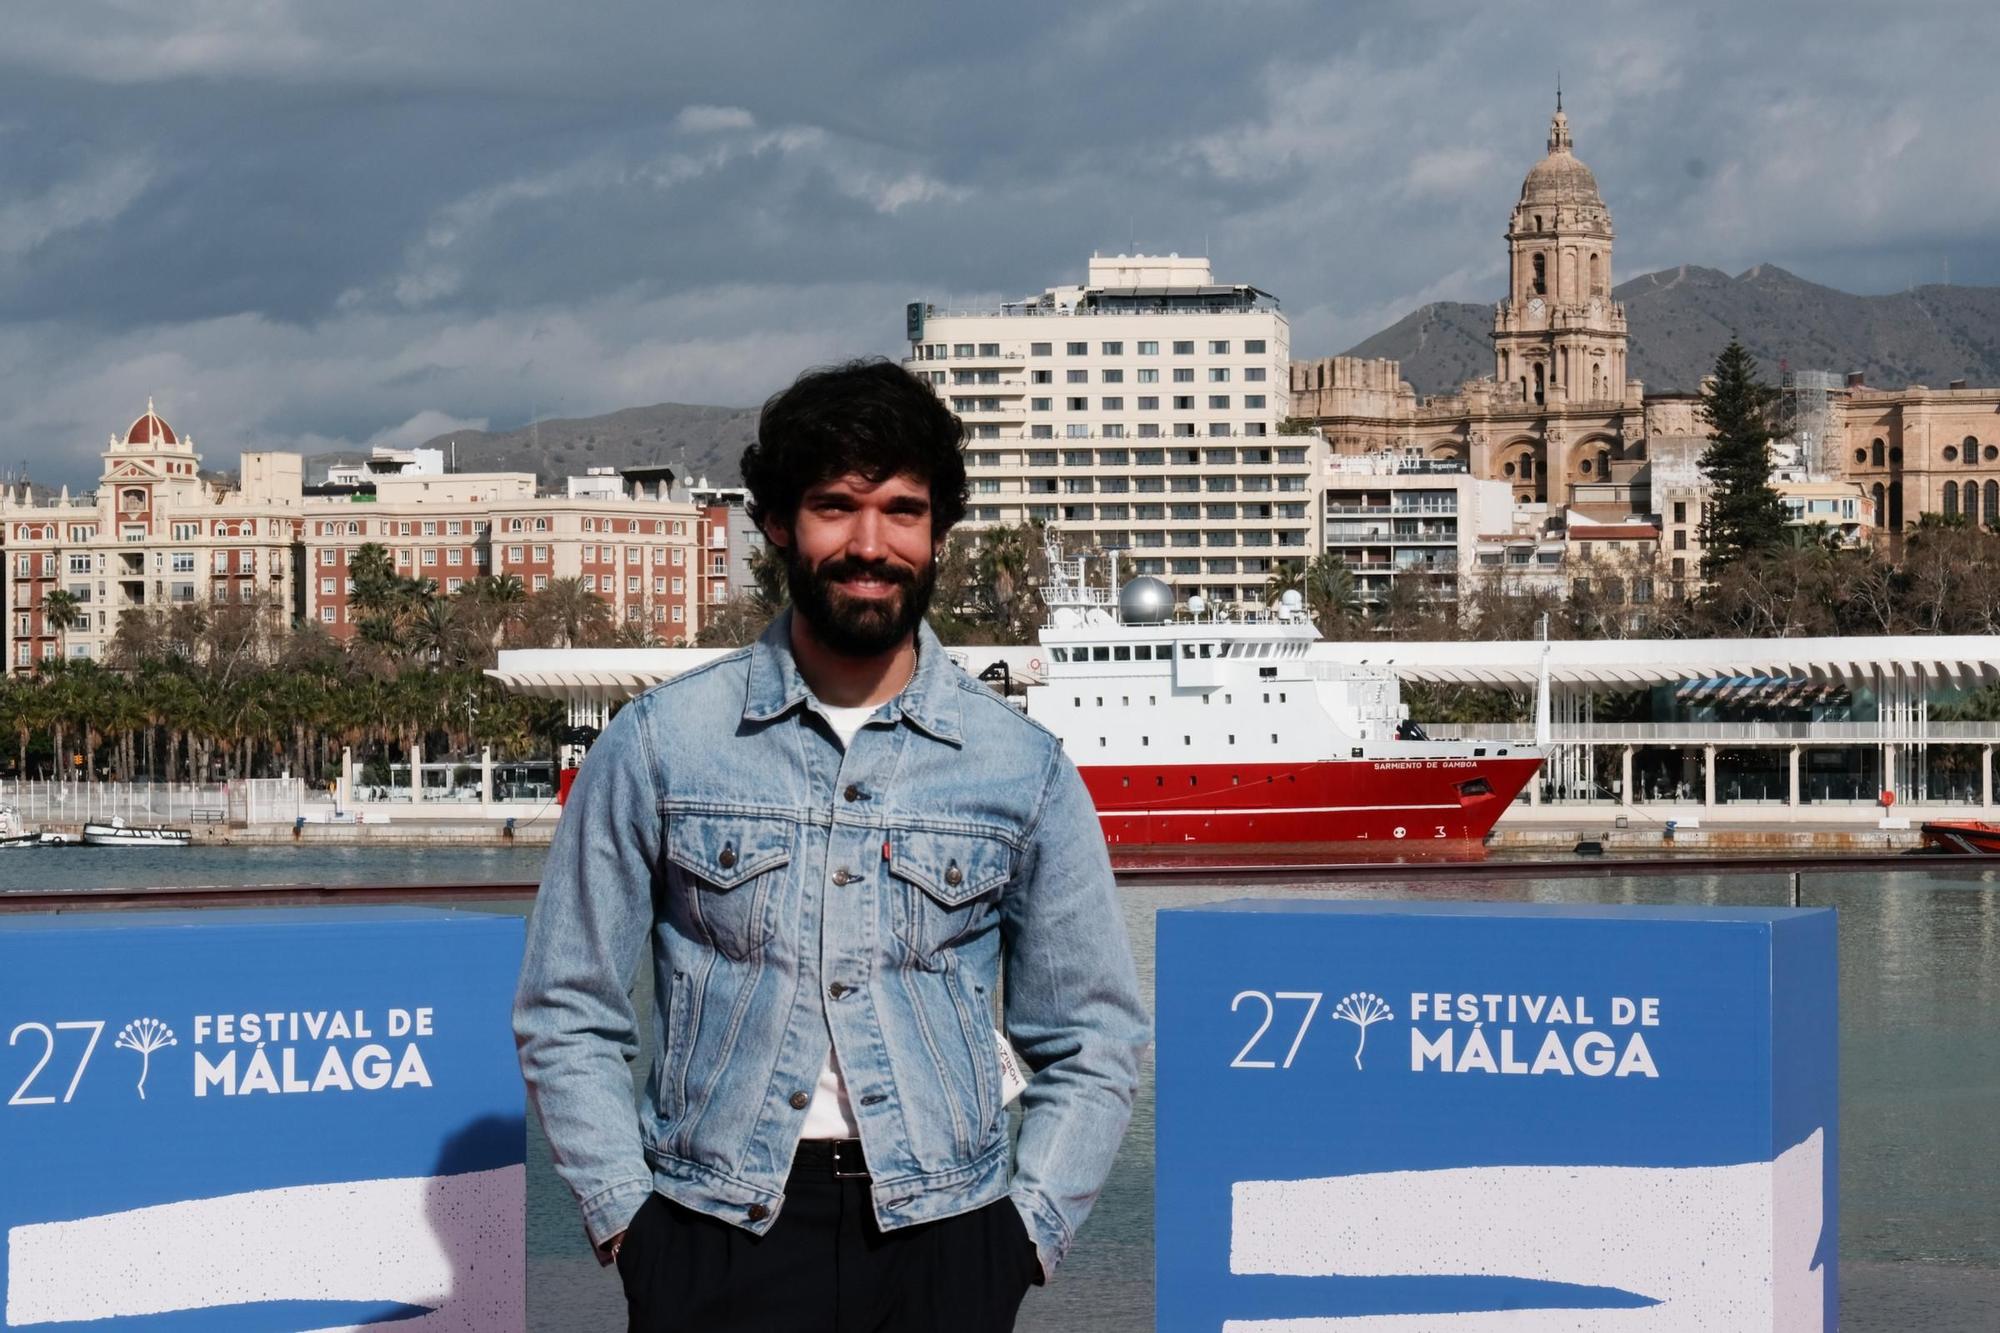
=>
[1410,991,1660,1079]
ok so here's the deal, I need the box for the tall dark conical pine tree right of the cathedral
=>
[1700,338,1786,578]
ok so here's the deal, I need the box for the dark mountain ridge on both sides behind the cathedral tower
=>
[1344,264,2000,394]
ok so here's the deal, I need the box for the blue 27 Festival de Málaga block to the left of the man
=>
[0,909,526,1333]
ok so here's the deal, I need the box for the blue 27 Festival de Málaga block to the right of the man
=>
[1156,901,1838,1333]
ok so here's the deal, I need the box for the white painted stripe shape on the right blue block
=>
[1222,1131,1826,1333]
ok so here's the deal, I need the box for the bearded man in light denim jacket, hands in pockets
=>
[514,362,1148,1333]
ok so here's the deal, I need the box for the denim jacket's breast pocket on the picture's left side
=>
[666,815,798,963]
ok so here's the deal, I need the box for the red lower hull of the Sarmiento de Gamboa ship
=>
[1080,757,1540,855]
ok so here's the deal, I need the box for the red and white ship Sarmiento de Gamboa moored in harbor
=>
[1026,536,1544,859]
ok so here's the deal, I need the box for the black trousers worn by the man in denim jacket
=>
[618,1165,1040,1333]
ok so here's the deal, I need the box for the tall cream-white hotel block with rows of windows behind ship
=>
[904,254,1318,604]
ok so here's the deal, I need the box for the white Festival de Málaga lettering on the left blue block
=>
[194,1007,432,1097]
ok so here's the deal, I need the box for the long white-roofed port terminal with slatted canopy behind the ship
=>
[488,636,2000,825]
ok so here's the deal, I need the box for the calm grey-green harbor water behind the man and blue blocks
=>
[0,847,2000,1333]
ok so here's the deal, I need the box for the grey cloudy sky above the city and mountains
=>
[0,0,2000,484]
